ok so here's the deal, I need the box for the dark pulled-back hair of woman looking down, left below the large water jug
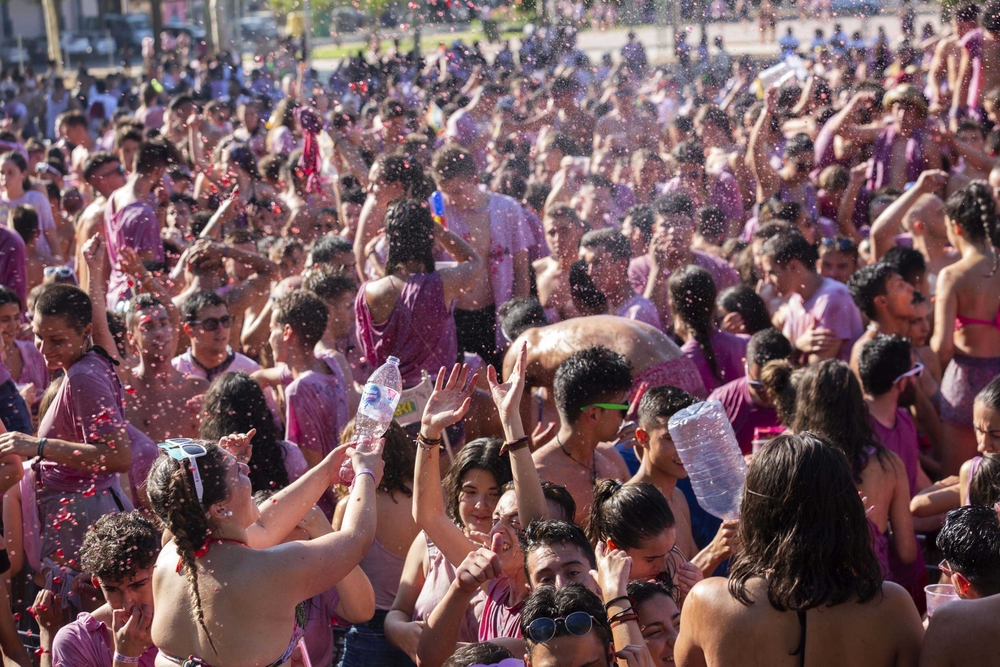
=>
[587,479,676,549]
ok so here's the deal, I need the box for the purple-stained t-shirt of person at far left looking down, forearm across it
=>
[38,350,128,493]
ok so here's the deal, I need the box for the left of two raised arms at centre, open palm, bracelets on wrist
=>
[413,364,479,566]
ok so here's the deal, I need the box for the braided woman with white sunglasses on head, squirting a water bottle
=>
[148,434,384,667]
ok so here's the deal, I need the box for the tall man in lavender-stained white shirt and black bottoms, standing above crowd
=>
[431,144,531,367]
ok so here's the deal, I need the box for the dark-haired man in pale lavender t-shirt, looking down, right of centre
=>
[760,233,864,364]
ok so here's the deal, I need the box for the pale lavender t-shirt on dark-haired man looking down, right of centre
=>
[782,278,865,361]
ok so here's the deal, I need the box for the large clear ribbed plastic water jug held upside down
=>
[667,401,747,520]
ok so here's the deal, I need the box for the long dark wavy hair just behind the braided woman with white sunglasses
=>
[198,372,289,491]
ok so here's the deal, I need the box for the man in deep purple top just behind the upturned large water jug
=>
[708,328,792,454]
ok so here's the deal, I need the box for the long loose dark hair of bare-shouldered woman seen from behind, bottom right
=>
[729,433,883,611]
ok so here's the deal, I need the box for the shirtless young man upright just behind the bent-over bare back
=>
[532,204,588,320]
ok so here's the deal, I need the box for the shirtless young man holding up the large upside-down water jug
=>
[629,386,739,577]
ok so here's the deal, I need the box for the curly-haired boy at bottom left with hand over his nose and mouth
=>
[47,511,160,667]
